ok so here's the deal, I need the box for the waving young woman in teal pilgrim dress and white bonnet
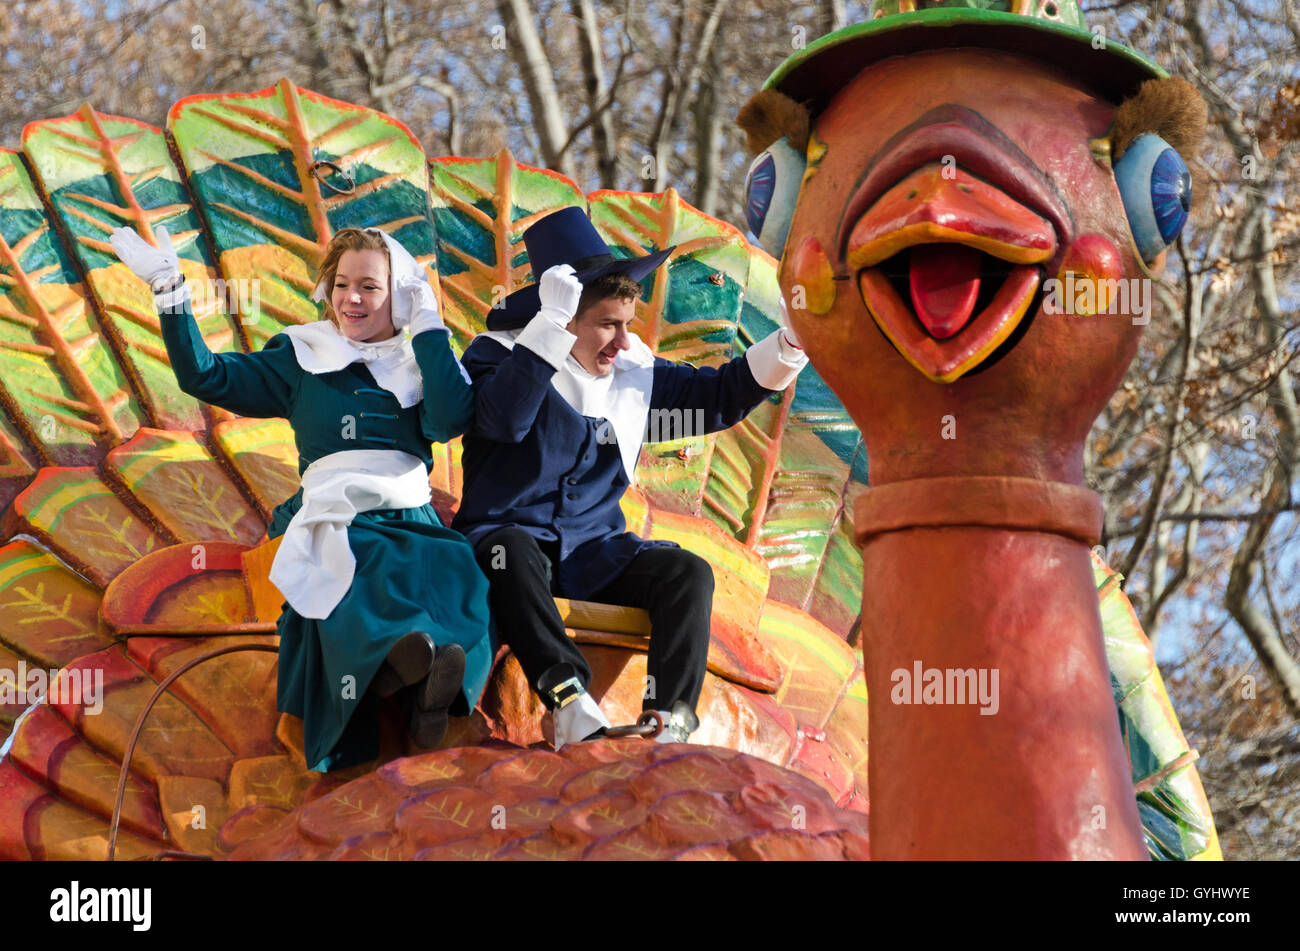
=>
[112,227,493,770]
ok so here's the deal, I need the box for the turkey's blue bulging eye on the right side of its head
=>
[1115,133,1192,261]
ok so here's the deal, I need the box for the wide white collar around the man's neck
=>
[476,330,655,482]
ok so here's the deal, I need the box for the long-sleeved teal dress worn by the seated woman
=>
[161,289,494,772]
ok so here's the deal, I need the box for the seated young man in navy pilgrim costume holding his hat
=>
[452,208,807,750]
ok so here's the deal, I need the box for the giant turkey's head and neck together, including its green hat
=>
[738,0,1205,859]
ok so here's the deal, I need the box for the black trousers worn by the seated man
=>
[475,526,714,709]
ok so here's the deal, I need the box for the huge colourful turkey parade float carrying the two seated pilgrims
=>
[0,3,1218,859]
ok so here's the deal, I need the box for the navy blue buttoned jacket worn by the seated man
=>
[451,336,774,599]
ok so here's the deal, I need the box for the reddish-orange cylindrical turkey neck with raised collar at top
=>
[855,477,1147,859]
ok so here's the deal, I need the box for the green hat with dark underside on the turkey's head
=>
[763,0,1167,116]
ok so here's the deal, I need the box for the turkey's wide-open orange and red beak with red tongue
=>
[844,107,1070,383]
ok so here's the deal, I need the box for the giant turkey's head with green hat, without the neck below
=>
[738,0,1205,485]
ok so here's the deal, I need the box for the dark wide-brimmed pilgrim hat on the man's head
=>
[488,205,677,330]
